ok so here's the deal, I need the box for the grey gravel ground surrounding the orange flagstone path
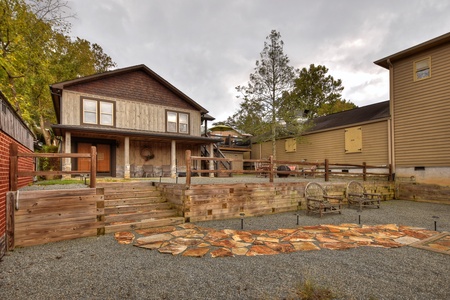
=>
[0,200,450,299]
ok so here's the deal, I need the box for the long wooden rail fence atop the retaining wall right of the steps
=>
[186,150,393,185]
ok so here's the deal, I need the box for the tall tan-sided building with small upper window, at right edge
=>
[375,33,450,186]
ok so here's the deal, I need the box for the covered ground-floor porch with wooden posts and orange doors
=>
[53,125,220,178]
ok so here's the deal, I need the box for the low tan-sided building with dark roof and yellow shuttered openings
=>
[252,101,391,166]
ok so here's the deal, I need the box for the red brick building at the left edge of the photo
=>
[0,92,35,258]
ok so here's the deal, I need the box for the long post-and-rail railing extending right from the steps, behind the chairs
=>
[186,150,393,185]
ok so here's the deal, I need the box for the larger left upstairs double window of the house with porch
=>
[82,99,114,126]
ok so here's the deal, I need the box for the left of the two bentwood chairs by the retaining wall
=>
[305,182,343,217]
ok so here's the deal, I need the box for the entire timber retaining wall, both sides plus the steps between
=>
[7,181,394,249]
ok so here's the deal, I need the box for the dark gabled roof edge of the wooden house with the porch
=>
[50,64,212,123]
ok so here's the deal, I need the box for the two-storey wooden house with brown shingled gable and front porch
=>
[50,65,220,178]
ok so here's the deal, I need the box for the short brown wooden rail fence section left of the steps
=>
[9,144,97,191]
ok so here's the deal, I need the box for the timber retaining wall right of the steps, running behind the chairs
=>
[155,181,395,222]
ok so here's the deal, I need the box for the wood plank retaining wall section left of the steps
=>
[10,189,104,246]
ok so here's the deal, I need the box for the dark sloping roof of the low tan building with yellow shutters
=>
[306,100,390,133]
